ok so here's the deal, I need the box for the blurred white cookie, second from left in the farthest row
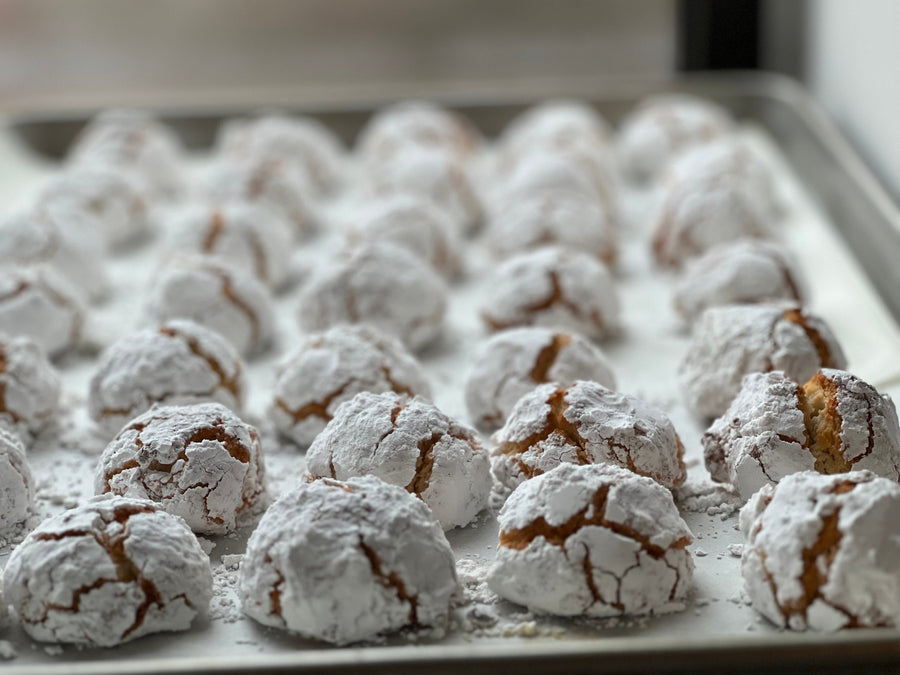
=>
[216,114,344,194]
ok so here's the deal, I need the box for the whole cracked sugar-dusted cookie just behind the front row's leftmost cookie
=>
[94,403,266,534]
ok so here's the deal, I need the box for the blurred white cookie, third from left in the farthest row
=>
[356,101,480,166]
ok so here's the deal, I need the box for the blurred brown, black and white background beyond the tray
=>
[0,0,900,197]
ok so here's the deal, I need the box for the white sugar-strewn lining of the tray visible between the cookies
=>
[0,100,900,665]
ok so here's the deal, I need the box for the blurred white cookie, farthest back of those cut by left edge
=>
[0,209,109,300]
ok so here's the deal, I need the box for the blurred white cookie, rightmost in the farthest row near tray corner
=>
[617,94,734,182]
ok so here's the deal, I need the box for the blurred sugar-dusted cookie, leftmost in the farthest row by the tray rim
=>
[69,109,184,198]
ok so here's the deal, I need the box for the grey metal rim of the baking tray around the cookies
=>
[0,73,900,673]
